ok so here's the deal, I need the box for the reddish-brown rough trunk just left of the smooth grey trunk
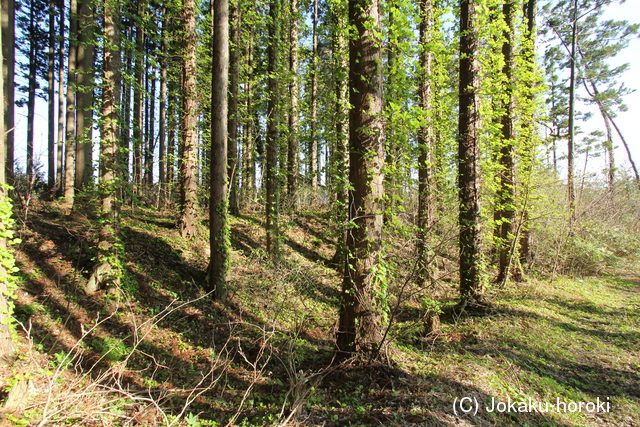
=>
[179,0,198,238]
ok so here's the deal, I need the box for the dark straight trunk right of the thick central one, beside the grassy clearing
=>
[458,0,480,303]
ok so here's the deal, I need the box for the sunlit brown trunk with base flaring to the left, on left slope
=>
[85,0,121,294]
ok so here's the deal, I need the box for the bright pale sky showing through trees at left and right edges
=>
[8,0,640,186]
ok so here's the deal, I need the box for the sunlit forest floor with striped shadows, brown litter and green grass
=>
[0,203,640,427]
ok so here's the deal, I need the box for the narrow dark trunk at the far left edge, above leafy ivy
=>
[0,0,16,185]
